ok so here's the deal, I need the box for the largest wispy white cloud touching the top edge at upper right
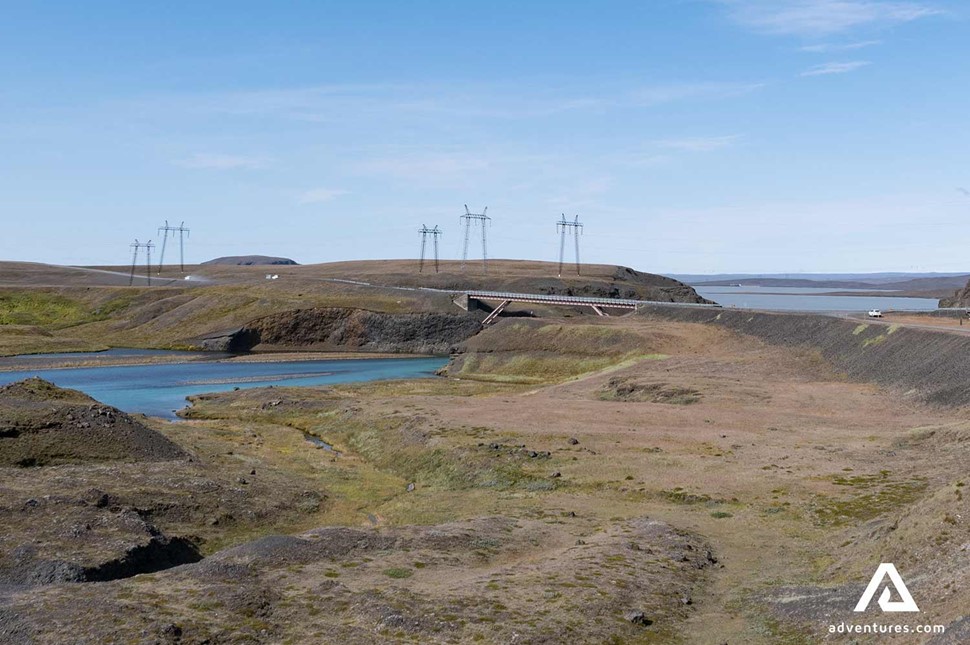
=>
[715,0,943,37]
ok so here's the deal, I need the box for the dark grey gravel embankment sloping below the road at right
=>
[640,307,970,406]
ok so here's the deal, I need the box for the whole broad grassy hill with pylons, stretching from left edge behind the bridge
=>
[0,260,699,355]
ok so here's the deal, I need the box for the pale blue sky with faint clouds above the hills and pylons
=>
[0,0,970,273]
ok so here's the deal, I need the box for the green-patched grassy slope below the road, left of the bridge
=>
[0,283,446,355]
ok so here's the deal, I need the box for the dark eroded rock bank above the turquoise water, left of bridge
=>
[219,307,481,354]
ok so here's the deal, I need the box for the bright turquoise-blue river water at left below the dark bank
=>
[0,350,448,419]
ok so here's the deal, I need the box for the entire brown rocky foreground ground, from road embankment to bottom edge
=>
[0,316,970,644]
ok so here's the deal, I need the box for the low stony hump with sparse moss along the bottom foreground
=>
[0,517,716,643]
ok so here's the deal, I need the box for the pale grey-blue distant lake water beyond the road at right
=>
[694,286,939,312]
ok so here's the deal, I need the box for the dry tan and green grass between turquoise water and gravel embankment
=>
[3,310,970,644]
